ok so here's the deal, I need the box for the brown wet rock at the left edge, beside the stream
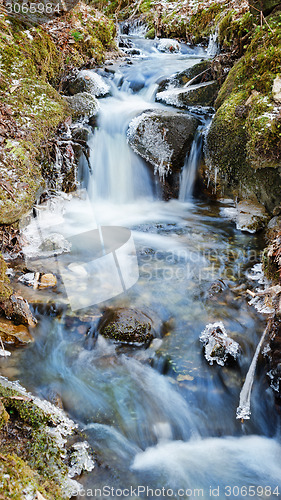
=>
[0,294,37,327]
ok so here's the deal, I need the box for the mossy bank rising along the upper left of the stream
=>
[0,3,115,224]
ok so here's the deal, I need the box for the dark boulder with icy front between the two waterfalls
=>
[127,110,198,179]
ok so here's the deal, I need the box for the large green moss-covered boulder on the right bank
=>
[203,8,281,211]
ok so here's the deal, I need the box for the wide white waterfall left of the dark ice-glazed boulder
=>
[89,91,153,203]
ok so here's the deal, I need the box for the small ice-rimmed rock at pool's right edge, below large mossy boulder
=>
[236,200,268,233]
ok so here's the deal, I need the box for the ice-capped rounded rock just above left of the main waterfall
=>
[68,69,110,97]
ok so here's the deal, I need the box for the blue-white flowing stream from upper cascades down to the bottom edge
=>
[0,35,281,499]
